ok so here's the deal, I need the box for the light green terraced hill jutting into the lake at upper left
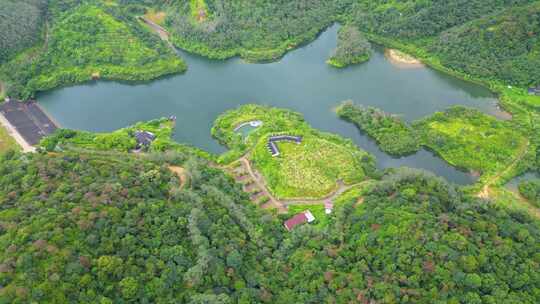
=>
[0,3,186,99]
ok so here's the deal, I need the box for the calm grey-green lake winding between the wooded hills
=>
[38,25,497,184]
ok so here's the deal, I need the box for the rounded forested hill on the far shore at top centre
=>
[166,0,345,61]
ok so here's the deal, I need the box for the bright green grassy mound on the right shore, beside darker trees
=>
[415,107,528,178]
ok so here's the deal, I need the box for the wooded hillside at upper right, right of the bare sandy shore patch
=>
[429,2,540,86]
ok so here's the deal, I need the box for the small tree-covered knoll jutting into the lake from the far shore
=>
[327,25,372,68]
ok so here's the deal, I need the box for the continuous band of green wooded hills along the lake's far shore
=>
[0,0,540,97]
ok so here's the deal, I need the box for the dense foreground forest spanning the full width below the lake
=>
[0,152,540,303]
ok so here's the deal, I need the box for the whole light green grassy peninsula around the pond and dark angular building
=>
[212,105,373,199]
